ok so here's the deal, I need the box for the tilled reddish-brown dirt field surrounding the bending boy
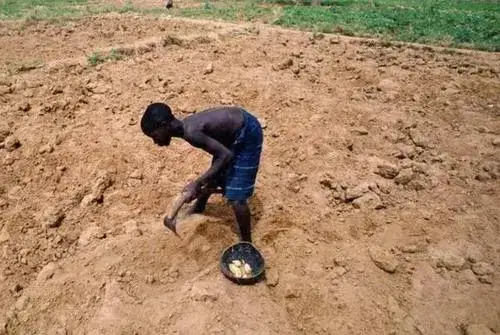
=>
[0,11,500,335]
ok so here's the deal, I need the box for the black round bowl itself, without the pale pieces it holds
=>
[220,242,265,285]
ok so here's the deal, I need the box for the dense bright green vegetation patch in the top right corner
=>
[275,0,500,51]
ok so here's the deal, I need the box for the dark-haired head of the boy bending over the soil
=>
[141,102,176,146]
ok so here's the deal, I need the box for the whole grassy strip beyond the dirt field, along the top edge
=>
[0,0,500,51]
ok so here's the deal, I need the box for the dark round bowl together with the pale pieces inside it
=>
[220,242,265,285]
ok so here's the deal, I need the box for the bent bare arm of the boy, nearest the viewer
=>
[186,131,233,201]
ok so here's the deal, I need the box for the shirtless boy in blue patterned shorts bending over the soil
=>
[141,103,263,242]
